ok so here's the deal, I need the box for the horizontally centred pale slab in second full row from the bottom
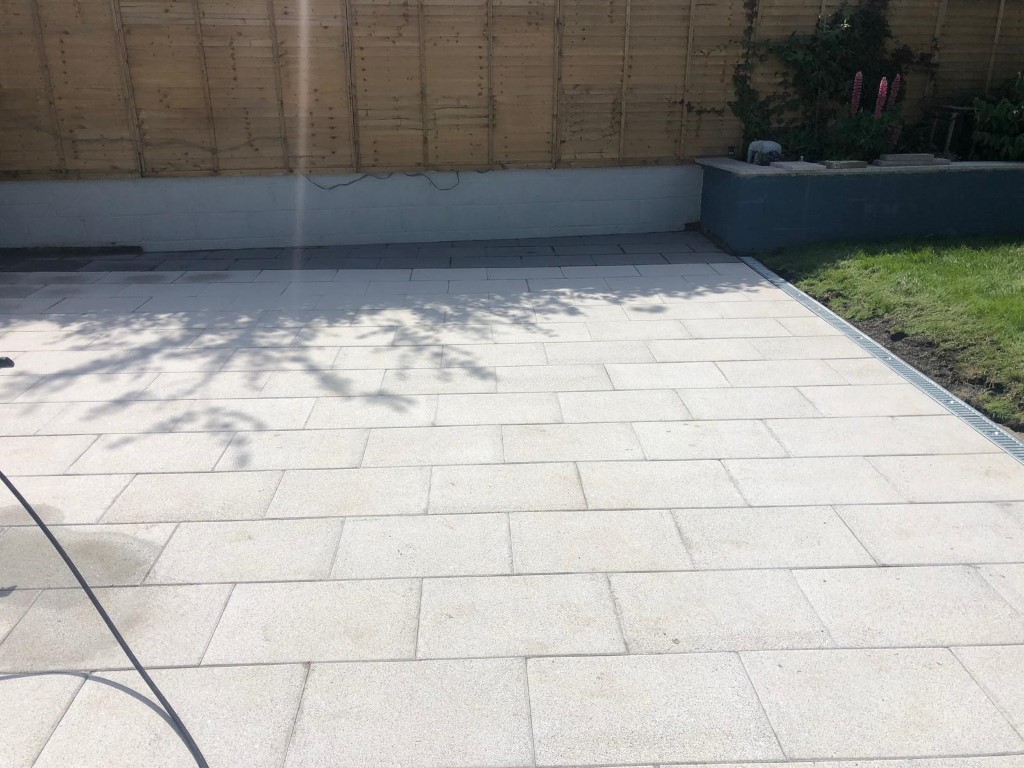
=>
[417,573,626,658]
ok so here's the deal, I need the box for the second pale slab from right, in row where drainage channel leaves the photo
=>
[720,457,906,507]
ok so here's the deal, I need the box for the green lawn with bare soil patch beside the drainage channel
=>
[759,239,1024,431]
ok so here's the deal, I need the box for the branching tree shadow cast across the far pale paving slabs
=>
[0,264,777,465]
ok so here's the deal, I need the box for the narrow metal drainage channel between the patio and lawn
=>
[739,256,1024,464]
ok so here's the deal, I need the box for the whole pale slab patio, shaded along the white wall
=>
[0,231,1024,768]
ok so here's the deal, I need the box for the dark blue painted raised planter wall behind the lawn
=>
[697,158,1024,254]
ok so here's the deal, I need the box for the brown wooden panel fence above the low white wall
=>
[0,0,1024,178]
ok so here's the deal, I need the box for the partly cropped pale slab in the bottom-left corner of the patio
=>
[0,674,85,768]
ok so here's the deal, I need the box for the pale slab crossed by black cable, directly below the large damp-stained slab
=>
[0,584,231,672]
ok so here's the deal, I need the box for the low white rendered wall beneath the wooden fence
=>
[0,165,701,251]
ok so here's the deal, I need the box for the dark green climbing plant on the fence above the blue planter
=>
[729,0,930,160]
